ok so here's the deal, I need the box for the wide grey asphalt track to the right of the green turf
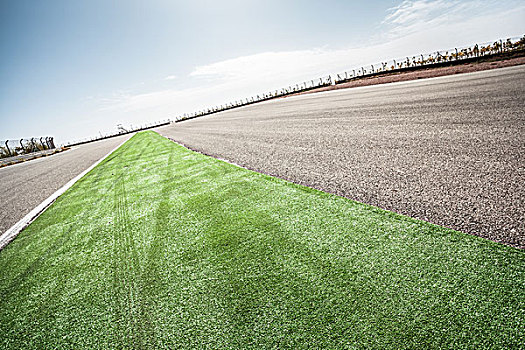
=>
[156,66,525,248]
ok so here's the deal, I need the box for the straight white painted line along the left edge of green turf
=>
[0,134,134,250]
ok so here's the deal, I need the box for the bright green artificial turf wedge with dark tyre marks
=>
[0,132,525,349]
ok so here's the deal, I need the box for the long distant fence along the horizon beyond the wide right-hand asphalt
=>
[175,36,525,122]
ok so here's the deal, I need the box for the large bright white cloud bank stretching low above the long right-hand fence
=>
[97,0,525,124]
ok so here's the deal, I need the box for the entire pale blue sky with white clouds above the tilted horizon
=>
[0,0,525,144]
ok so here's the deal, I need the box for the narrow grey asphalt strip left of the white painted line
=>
[0,135,131,234]
